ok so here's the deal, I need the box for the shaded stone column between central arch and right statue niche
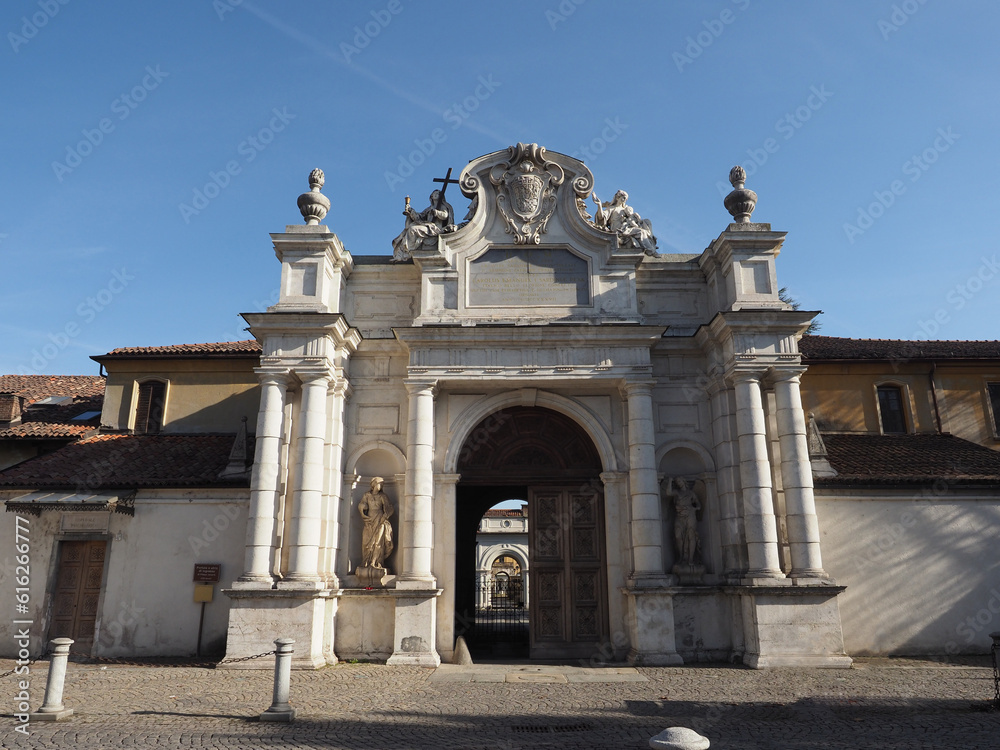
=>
[625,383,664,583]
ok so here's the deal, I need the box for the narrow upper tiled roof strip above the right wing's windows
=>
[799,336,1000,362]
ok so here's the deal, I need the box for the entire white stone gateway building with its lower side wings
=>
[0,144,1000,668]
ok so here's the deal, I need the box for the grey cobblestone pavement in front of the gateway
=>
[0,657,1000,750]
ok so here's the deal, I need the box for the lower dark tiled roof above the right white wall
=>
[816,434,1000,486]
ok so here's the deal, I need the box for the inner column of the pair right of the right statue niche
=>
[731,371,784,579]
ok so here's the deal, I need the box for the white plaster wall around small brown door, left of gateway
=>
[0,490,248,656]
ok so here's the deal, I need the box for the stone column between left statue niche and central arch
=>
[397,381,436,588]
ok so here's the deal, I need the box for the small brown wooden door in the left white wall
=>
[49,541,107,654]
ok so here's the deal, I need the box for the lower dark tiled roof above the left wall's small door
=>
[0,434,253,492]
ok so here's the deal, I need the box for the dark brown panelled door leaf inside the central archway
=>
[528,487,607,659]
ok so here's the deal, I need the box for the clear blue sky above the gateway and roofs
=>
[0,0,1000,374]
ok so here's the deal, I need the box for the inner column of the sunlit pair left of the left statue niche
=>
[278,372,330,588]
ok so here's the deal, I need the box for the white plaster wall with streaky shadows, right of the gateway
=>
[817,488,1000,655]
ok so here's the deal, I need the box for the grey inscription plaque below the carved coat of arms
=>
[468,247,590,307]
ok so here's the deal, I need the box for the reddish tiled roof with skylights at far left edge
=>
[0,375,104,440]
